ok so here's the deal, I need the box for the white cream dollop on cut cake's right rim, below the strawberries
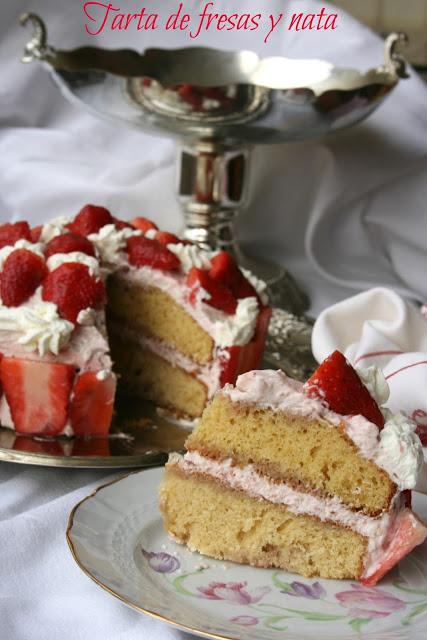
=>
[214,297,258,347]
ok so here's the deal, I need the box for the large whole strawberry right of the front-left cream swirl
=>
[42,262,105,323]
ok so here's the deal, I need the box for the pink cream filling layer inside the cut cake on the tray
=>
[108,322,226,398]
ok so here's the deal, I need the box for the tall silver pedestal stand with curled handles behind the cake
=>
[20,13,407,379]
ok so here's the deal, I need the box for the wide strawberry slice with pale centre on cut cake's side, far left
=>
[0,358,75,435]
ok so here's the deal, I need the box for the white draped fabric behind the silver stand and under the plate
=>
[0,0,427,640]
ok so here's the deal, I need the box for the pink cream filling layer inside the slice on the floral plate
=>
[169,451,404,576]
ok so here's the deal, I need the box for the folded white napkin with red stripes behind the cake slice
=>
[312,287,427,444]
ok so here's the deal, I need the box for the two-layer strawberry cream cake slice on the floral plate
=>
[160,352,427,585]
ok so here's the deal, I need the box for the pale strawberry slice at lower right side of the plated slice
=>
[361,509,427,587]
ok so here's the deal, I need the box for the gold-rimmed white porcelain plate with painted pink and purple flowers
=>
[67,469,427,640]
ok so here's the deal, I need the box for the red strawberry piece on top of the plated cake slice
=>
[304,351,384,429]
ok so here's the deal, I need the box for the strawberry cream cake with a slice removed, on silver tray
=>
[0,205,271,436]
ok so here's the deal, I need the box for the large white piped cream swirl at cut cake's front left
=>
[0,302,74,356]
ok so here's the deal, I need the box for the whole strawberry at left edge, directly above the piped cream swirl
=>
[0,249,47,307]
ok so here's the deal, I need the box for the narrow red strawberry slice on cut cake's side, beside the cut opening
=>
[70,371,116,436]
